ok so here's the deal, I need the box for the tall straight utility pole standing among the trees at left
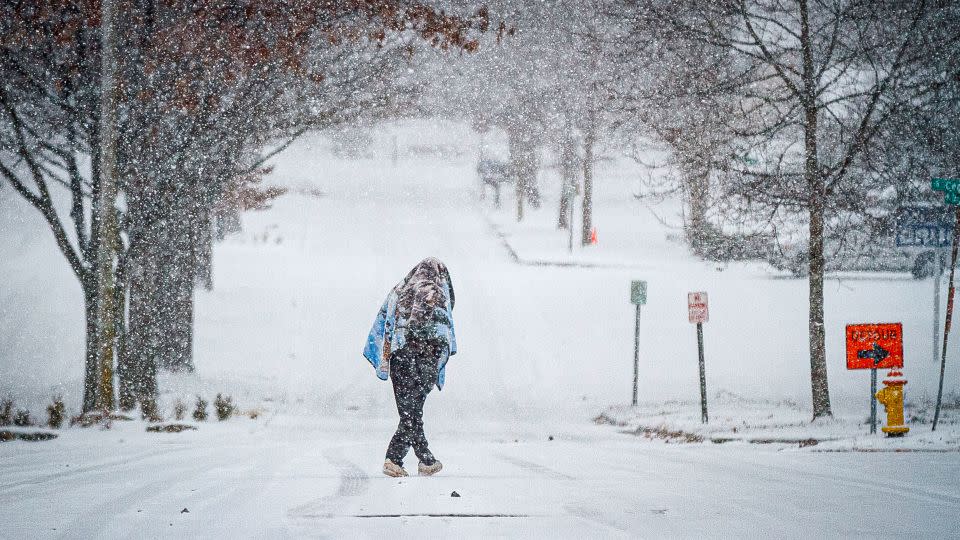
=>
[92,0,119,411]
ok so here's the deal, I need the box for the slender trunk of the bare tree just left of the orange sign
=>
[799,0,833,419]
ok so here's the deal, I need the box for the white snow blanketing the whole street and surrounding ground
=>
[0,123,960,538]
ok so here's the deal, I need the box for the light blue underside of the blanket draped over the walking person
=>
[363,264,457,390]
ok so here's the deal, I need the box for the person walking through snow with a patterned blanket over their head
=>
[363,257,457,477]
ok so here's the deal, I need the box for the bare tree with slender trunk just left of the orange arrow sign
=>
[621,0,944,418]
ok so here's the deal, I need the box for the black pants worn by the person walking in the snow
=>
[387,338,446,467]
